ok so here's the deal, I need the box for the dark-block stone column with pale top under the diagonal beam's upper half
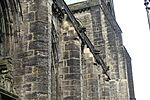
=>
[61,21,81,100]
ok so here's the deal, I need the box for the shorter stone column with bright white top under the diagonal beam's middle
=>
[82,48,100,100]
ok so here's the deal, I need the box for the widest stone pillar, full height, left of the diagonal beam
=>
[15,0,52,100]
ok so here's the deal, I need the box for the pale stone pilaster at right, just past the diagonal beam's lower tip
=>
[101,8,119,100]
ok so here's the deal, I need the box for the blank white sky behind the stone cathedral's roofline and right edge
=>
[65,0,150,100]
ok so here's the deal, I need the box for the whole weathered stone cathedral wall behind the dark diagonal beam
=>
[0,0,135,100]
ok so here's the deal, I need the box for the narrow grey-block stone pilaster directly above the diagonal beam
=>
[90,6,106,59]
